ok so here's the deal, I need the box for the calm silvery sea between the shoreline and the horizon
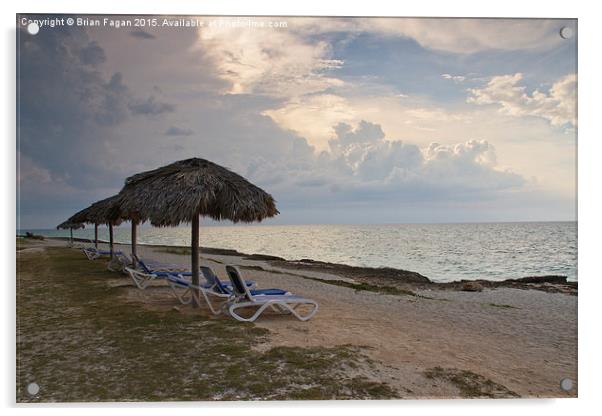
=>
[21,222,577,282]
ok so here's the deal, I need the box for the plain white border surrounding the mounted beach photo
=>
[0,0,602,416]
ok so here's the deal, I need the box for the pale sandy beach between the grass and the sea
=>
[19,239,578,399]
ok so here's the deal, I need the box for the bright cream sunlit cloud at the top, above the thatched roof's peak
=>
[198,22,343,98]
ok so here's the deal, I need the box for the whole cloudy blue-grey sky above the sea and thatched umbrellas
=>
[17,15,577,228]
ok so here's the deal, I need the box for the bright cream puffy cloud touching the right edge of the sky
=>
[467,73,577,127]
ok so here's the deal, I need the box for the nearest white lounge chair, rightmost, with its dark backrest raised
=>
[225,266,318,322]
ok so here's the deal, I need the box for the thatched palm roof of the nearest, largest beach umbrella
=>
[118,158,279,226]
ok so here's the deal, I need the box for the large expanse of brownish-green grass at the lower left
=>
[17,247,398,402]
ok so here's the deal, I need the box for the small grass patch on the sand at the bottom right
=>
[424,367,520,399]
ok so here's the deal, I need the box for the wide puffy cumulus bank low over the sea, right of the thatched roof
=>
[247,120,526,203]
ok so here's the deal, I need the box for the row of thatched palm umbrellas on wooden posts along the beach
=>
[57,158,278,307]
